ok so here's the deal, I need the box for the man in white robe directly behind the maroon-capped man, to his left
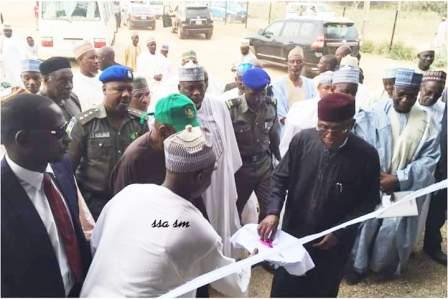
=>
[280,71,333,157]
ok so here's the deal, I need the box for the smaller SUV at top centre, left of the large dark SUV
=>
[172,5,213,39]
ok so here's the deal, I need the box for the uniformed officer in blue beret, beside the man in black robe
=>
[226,67,280,223]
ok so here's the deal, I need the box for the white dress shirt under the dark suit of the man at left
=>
[5,154,74,295]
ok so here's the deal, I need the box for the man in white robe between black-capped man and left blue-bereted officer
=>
[73,42,104,111]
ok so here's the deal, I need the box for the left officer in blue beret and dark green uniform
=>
[67,65,148,220]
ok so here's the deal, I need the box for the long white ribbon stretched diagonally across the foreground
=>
[159,179,448,298]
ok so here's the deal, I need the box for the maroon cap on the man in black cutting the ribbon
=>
[317,92,355,122]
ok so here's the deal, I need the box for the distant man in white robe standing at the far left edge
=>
[0,25,25,87]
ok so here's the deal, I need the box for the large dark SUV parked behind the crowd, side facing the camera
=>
[248,17,359,77]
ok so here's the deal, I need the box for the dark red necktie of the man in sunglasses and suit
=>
[44,173,82,282]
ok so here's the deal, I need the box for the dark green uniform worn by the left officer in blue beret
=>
[67,105,148,219]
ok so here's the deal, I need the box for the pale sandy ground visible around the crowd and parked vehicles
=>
[0,0,447,297]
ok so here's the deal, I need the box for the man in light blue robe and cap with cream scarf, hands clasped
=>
[346,68,440,284]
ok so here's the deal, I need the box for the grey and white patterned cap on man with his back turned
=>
[163,125,216,173]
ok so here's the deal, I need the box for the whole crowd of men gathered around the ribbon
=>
[1,21,447,297]
